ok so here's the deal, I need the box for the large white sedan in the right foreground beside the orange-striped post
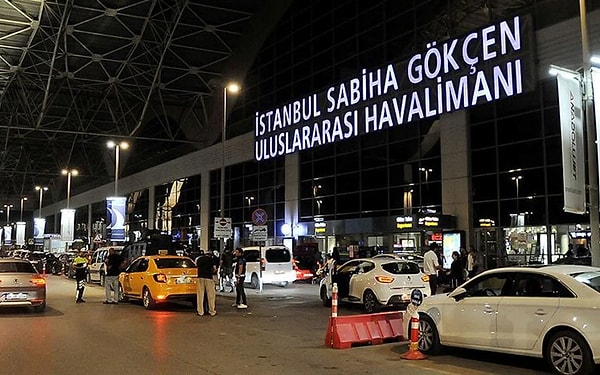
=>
[417,265,600,375]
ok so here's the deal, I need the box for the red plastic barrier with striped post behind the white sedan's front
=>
[325,284,404,349]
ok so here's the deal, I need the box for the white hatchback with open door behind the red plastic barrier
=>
[319,258,431,313]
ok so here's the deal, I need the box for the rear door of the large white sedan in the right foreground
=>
[497,272,560,350]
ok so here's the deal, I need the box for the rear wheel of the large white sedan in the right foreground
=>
[544,331,594,375]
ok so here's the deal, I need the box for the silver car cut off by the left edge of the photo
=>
[0,258,46,312]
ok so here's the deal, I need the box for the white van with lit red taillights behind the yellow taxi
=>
[242,246,296,289]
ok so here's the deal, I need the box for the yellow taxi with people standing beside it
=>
[119,255,198,310]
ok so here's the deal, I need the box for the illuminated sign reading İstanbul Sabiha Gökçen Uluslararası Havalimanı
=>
[254,16,535,161]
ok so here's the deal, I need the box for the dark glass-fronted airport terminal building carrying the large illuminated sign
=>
[36,0,600,267]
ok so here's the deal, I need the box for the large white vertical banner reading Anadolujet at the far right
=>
[557,72,585,214]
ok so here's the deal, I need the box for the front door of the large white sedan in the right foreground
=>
[440,273,509,348]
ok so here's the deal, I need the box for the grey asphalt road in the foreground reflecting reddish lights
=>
[0,276,547,375]
